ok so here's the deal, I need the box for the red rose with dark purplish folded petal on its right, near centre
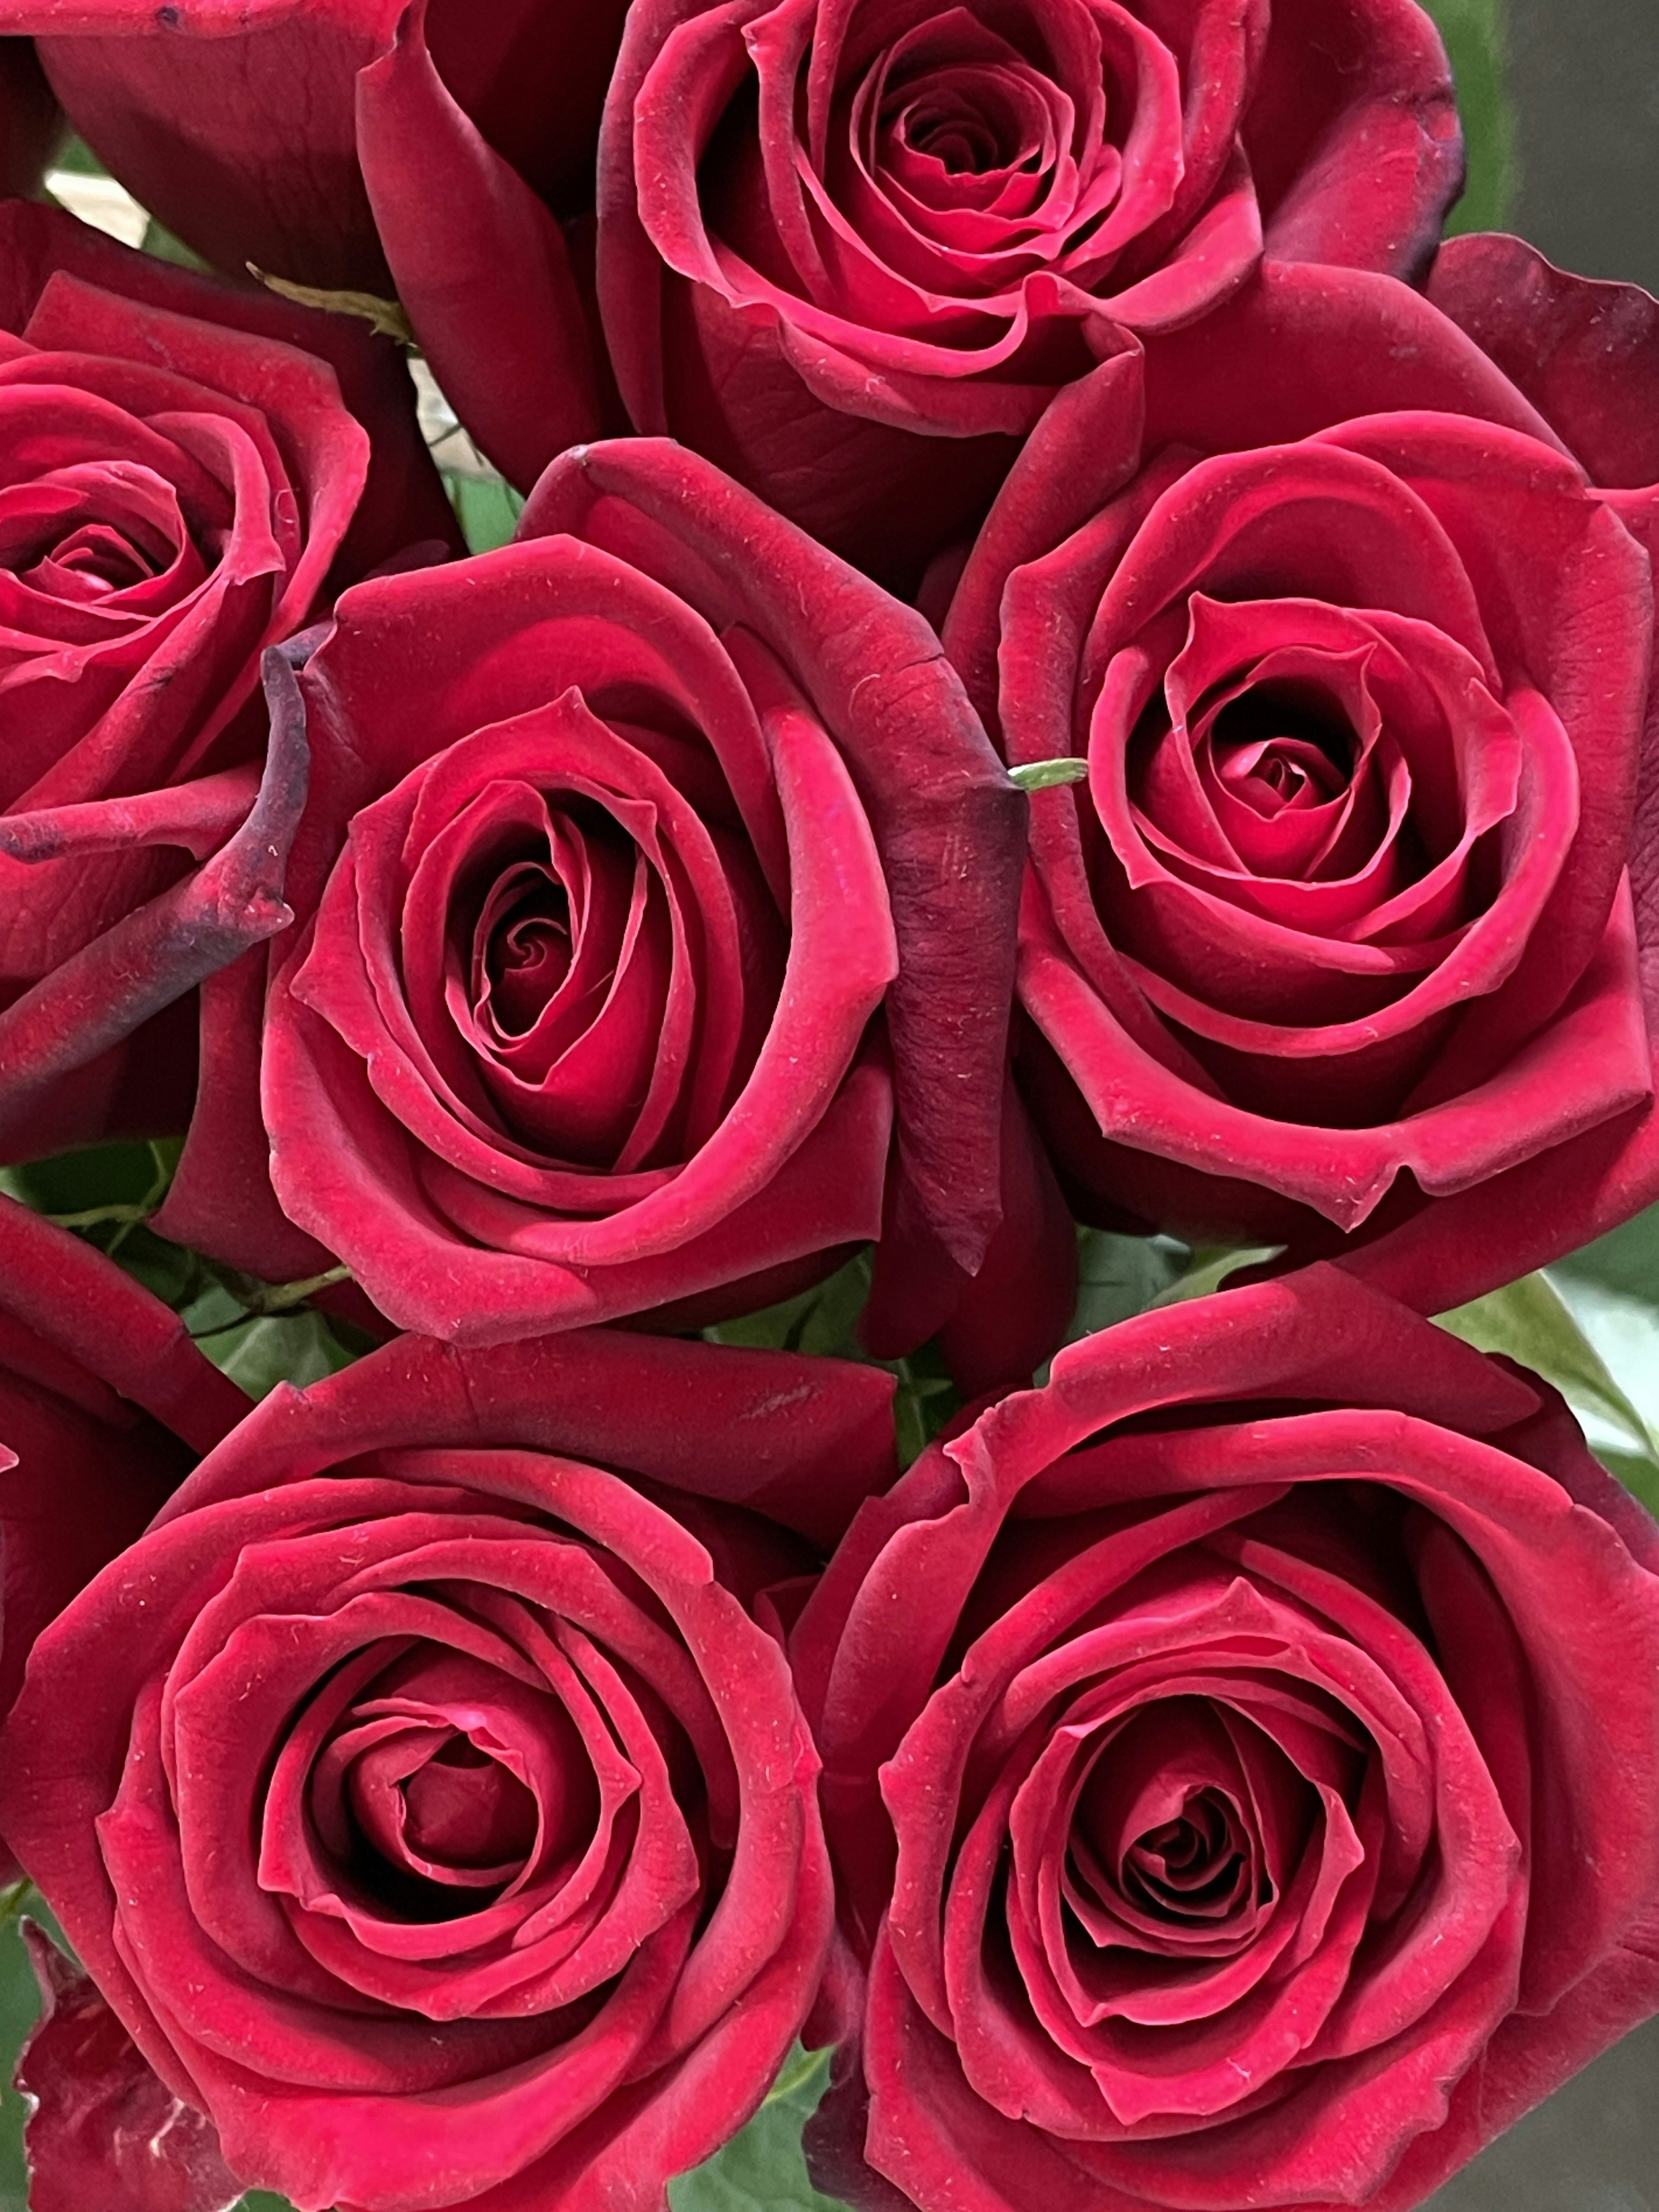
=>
[162,440,1064,1371]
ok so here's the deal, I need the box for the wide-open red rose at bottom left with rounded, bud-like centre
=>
[0,1332,911,2212]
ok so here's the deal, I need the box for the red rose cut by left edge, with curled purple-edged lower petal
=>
[0,203,454,1159]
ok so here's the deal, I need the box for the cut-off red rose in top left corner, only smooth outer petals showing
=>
[0,0,626,486]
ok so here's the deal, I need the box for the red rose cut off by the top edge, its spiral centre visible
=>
[600,0,1462,575]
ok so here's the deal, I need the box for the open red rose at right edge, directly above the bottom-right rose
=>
[944,239,1659,1309]
